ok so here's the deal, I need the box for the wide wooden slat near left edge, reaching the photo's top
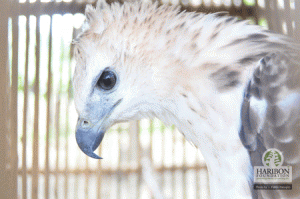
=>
[9,0,19,198]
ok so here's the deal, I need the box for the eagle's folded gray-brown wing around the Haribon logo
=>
[240,53,300,198]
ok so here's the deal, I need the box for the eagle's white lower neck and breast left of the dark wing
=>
[160,86,253,199]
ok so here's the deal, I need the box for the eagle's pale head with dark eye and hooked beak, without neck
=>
[73,1,184,158]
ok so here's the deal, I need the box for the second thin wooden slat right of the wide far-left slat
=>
[32,12,40,199]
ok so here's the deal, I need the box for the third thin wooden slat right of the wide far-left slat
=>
[45,16,52,199]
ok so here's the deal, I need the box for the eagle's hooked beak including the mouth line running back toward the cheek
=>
[76,99,122,159]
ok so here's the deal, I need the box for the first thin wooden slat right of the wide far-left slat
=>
[22,13,30,199]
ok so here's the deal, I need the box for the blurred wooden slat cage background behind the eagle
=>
[0,0,300,199]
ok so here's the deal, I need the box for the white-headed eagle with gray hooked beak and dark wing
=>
[73,0,300,199]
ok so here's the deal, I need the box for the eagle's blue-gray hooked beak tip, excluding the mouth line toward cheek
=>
[76,120,105,159]
